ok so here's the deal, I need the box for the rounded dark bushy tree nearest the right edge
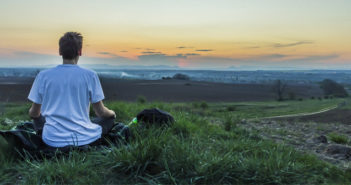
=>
[320,79,349,98]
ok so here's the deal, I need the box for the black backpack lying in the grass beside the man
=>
[137,108,174,126]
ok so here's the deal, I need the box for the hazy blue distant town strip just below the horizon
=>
[0,67,351,85]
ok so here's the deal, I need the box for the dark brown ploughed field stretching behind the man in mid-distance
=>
[0,78,322,102]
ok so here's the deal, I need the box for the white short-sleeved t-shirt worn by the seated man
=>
[28,64,104,147]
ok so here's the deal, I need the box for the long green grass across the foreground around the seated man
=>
[0,99,351,184]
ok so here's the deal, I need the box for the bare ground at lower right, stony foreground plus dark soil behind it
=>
[240,109,351,169]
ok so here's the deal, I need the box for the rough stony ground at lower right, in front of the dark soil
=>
[240,117,351,169]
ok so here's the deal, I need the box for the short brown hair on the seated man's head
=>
[59,32,83,60]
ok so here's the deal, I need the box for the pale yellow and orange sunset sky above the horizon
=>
[0,0,351,70]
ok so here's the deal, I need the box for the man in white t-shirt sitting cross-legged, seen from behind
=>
[28,32,116,147]
